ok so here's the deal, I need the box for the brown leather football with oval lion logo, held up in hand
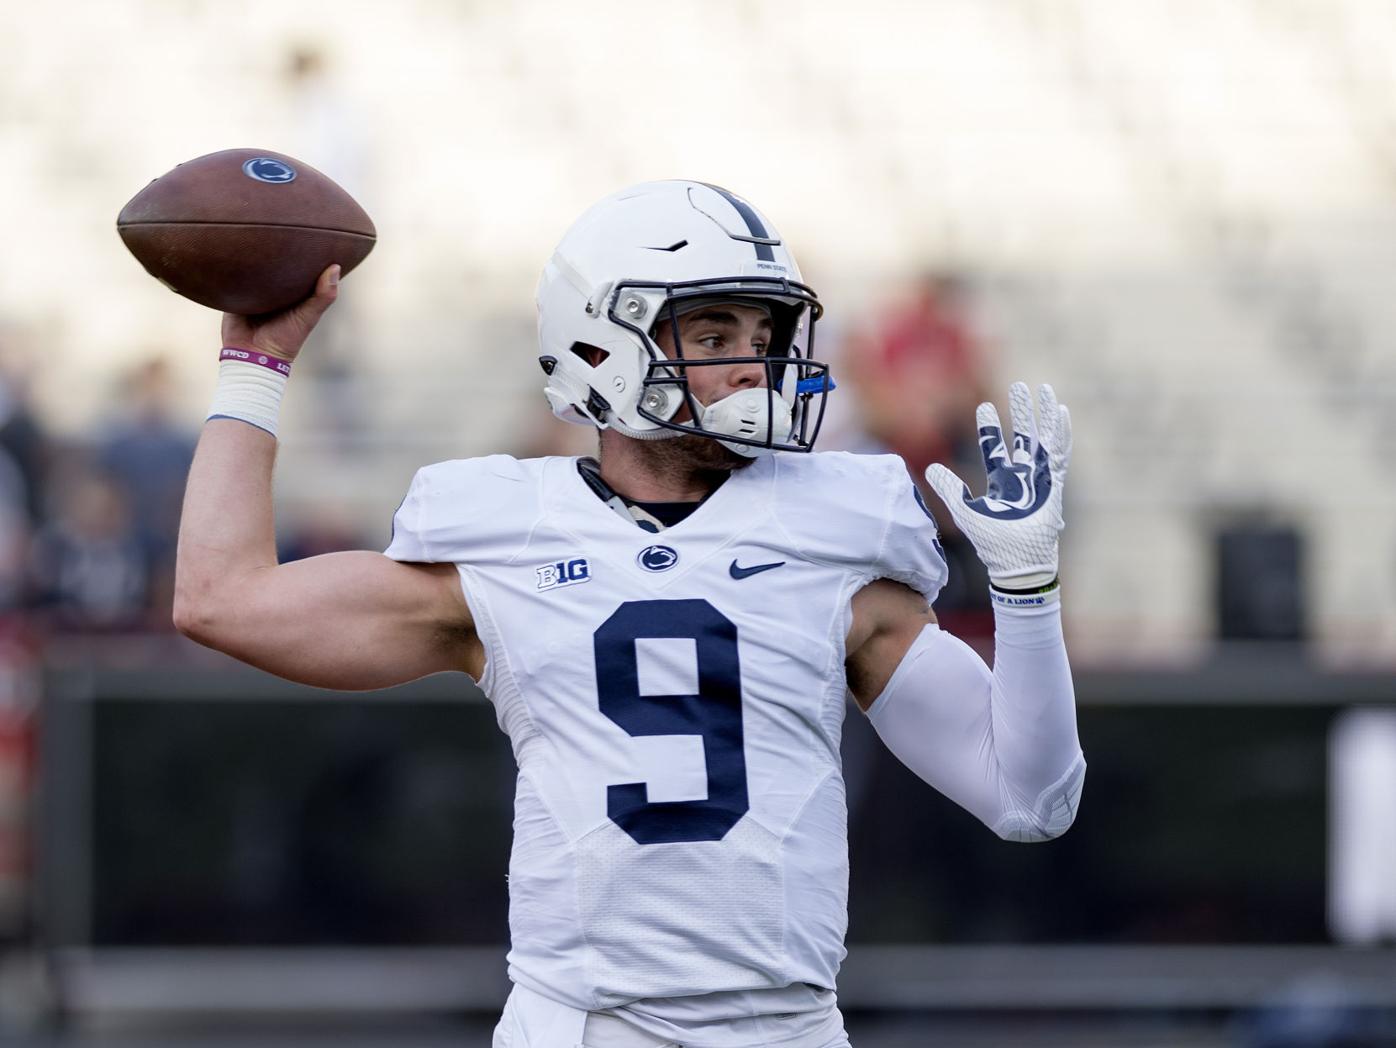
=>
[116,149,377,314]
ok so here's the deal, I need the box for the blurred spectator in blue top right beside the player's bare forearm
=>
[98,357,195,627]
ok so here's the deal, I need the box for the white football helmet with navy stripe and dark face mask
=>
[537,180,833,456]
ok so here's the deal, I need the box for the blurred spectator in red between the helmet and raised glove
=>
[845,272,1002,647]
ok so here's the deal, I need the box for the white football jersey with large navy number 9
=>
[387,454,945,1015]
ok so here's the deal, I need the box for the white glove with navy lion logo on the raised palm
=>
[926,382,1071,590]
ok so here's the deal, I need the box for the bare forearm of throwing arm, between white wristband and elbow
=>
[175,419,276,628]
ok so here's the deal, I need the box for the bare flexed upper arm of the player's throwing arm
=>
[194,551,484,691]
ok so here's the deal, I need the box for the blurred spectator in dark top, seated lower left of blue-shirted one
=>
[34,461,149,629]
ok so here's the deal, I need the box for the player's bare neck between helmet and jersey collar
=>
[597,431,750,502]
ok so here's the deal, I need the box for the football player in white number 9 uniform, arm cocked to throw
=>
[175,181,1086,1048]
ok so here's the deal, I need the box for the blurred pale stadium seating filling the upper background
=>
[10,0,1396,661]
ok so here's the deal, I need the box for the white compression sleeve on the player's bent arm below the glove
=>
[868,600,1086,841]
